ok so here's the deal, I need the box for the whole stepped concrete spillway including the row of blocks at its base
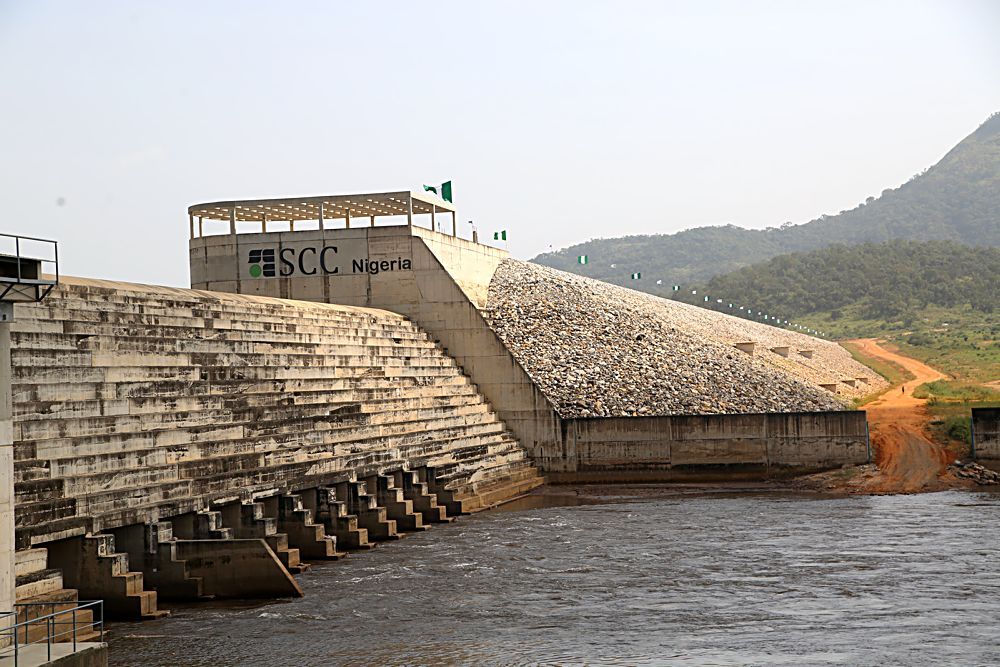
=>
[12,279,541,616]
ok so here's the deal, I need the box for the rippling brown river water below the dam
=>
[110,491,1000,667]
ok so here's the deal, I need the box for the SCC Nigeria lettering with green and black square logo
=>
[247,245,412,278]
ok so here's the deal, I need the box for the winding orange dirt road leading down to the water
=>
[854,338,953,493]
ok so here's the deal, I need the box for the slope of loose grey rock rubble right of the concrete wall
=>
[484,260,884,417]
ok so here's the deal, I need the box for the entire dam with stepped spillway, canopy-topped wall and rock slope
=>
[10,192,882,636]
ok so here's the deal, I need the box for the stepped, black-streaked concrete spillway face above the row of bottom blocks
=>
[12,279,540,547]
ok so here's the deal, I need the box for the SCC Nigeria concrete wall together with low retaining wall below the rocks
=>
[191,226,867,479]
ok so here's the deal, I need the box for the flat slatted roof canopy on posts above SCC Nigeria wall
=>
[188,191,455,222]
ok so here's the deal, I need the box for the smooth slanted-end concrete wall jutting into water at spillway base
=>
[176,539,302,598]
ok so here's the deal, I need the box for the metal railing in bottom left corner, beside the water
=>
[0,600,104,667]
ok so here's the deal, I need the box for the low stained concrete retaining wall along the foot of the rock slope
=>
[549,411,869,482]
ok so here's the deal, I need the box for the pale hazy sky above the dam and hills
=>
[0,0,1000,285]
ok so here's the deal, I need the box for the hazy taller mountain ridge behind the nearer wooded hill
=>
[533,113,1000,292]
